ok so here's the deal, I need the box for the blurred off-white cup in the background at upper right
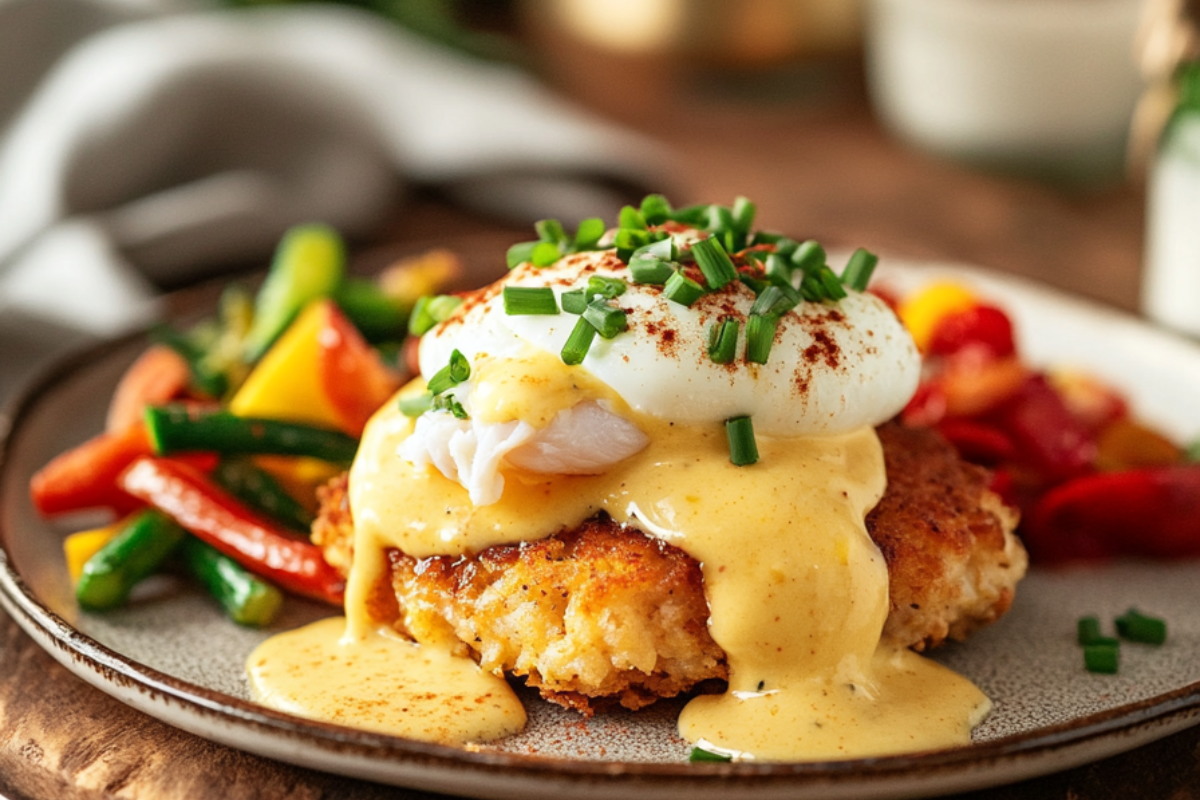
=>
[866,0,1142,182]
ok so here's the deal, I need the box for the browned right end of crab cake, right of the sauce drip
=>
[866,422,1028,651]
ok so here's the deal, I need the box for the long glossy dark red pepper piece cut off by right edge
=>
[1021,464,1200,563]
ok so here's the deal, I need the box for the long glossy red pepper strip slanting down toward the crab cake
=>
[120,458,346,606]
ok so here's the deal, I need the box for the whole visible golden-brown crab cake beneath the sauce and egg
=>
[313,423,1026,712]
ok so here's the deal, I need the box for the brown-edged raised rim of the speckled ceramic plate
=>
[0,264,1200,800]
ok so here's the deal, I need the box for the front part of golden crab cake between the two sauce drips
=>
[389,518,727,711]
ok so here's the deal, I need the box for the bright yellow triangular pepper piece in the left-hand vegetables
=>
[229,300,342,428]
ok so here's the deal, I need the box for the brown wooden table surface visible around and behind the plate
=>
[0,65,1200,800]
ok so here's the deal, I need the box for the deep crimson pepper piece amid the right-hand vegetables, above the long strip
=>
[989,373,1096,485]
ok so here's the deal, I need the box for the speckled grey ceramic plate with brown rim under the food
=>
[0,266,1200,800]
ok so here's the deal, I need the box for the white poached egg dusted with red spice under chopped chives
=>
[420,251,920,437]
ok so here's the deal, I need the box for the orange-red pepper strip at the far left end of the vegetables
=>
[29,422,217,516]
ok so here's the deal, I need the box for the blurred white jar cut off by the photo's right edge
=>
[1142,61,1200,336]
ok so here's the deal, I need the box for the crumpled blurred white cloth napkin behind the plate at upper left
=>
[0,0,664,395]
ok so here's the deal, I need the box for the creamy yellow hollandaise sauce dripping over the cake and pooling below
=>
[250,354,989,760]
